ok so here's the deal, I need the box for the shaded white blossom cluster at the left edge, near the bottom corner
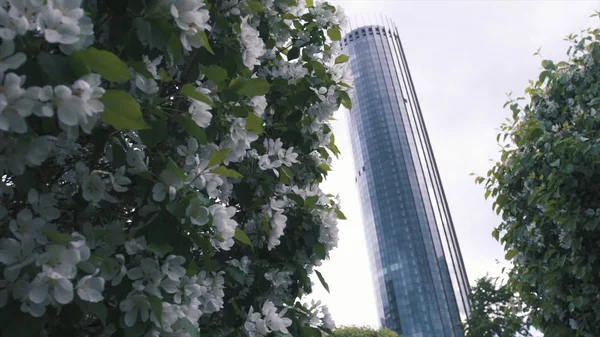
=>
[0,209,99,317]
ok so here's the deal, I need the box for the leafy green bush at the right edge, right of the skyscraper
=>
[478,29,600,336]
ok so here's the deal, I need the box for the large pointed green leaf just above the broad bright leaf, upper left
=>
[74,47,132,82]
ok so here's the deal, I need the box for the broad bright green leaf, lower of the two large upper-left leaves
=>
[100,90,150,130]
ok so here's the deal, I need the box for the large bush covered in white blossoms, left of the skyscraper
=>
[0,0,351,337]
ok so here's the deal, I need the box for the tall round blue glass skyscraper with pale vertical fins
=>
[343,24,470,337]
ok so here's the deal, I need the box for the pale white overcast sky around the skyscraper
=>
[311,0,600,326]
